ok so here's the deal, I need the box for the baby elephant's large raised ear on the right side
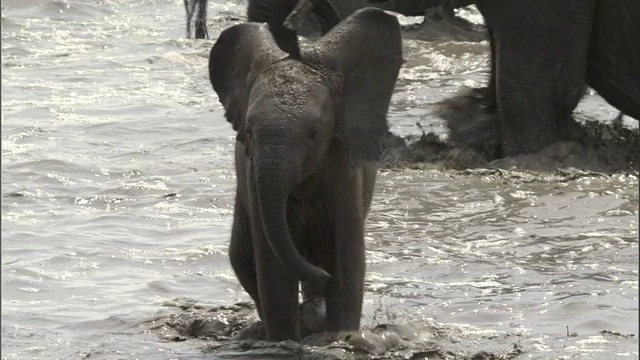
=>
[308,8,403,166]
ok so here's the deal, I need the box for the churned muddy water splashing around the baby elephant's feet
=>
[148,299,523,360]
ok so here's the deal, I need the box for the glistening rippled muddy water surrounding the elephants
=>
[2,0,638,359]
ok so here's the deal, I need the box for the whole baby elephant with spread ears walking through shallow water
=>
[209,8,402,341]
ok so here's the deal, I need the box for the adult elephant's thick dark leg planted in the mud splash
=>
[477,0,595,156]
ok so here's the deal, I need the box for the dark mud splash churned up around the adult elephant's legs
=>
[383,89,640,177]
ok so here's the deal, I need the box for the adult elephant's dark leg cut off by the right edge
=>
[587,1,640,120]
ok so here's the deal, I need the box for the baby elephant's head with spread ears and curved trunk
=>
[209,8,402,282]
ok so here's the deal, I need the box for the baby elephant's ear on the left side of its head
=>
[209,23,286,142]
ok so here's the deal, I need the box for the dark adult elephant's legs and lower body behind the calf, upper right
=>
[470,0,640,156]
